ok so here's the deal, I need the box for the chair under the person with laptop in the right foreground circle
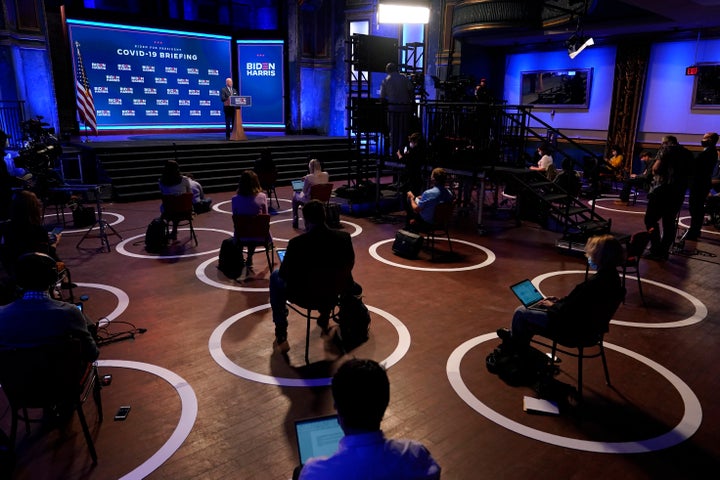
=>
[531,287,625,400]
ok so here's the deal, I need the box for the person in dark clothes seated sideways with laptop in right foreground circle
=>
[497,235,623,351]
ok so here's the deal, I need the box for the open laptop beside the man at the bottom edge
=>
[295,415,345,465]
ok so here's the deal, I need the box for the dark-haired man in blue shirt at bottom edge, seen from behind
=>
[299,358,440,480]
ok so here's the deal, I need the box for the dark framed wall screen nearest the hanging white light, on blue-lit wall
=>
[520,68,592,108]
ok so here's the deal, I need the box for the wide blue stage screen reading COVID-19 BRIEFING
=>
[67,19,232,131]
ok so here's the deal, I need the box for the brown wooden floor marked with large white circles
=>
[0,183,720,480]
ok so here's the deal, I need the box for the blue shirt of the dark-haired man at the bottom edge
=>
[300,430,440,480]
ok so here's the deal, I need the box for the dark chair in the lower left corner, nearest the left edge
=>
[0,338,103,465]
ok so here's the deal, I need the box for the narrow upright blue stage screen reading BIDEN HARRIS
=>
[237,40,285,129]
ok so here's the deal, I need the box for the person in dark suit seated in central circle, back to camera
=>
[270,200,355,353]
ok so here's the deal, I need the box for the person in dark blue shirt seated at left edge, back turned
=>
[0,252,100,362]
